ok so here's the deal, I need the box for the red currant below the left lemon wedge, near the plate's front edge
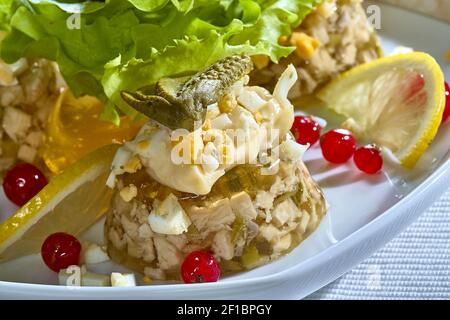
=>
[41,232,81,272]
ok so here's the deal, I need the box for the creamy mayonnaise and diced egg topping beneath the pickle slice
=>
[107,66,297,194]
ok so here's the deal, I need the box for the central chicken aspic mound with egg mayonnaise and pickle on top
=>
[105,56,326,280]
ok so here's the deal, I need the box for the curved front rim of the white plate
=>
[0,154,450,299]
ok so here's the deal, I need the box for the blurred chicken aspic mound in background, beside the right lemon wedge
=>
[250,0,382,99]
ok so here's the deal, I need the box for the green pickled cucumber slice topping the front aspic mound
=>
[121,56,253,131]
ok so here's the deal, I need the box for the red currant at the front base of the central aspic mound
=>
[181,251,220,283]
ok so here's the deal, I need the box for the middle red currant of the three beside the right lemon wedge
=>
[320,129,356,164]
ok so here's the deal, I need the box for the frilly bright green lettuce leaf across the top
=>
[0,0,322,123]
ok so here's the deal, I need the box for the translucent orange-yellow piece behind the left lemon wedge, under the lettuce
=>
[41,89,143,174]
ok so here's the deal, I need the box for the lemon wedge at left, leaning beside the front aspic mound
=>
[0,145,118,262]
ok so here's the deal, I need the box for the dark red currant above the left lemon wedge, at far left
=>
[3,163,47,206]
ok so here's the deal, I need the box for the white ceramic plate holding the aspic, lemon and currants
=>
[0,1,450,299]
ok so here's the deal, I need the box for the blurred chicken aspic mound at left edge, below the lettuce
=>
[0,58,60,176]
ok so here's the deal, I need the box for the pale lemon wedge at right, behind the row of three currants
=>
[317,52,445,168]
